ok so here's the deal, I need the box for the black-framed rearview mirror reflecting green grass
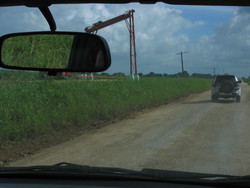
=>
[0,32,111,72]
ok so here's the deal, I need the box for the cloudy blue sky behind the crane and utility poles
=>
[0,3,250,77]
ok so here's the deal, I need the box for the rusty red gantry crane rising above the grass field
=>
[85,9,139,79]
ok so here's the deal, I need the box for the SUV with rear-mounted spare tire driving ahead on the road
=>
[211,75,241,102]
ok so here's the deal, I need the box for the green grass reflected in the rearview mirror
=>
[1,35,74,68]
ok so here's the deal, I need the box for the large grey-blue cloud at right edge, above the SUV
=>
[197,8,250,75]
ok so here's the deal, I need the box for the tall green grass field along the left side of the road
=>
[0,78,211,143]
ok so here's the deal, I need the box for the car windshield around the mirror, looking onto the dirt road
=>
[0,3,250,175]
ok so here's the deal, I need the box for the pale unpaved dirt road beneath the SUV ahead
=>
[13,84,250,175]
